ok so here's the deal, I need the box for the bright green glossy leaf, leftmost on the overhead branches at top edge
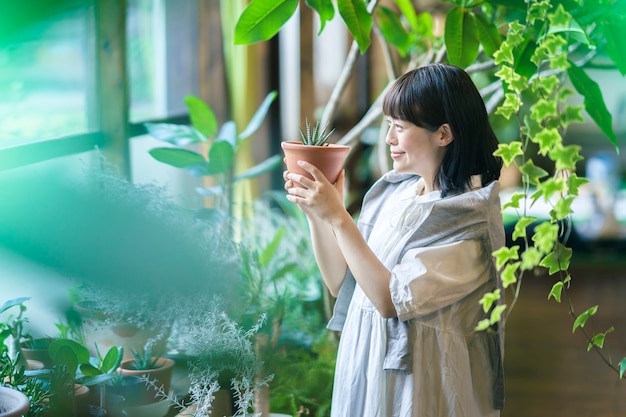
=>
[235,0,298,45]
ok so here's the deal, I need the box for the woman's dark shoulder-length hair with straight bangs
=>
[383,64,502,197]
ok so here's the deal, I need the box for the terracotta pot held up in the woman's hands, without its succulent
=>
[280,141,350,183]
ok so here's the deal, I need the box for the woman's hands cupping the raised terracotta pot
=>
[283,161,347,225]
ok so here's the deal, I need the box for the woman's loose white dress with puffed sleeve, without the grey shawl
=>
[331,174,501,417]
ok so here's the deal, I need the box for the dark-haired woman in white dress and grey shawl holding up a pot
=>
[285,64,504,417]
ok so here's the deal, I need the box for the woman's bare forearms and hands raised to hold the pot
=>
[286,161,396,318]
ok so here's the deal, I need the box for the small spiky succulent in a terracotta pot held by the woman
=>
[280,120,350,183]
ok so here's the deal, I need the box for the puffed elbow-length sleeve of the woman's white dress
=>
[389,240,490,321]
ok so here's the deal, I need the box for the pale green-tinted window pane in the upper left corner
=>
[0,2,93,147]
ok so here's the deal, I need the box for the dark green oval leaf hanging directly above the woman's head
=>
[444,6,479,68]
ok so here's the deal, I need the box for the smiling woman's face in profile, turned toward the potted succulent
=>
[385,117,451,183]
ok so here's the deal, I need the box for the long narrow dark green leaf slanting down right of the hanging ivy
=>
[567,62,617,148]
